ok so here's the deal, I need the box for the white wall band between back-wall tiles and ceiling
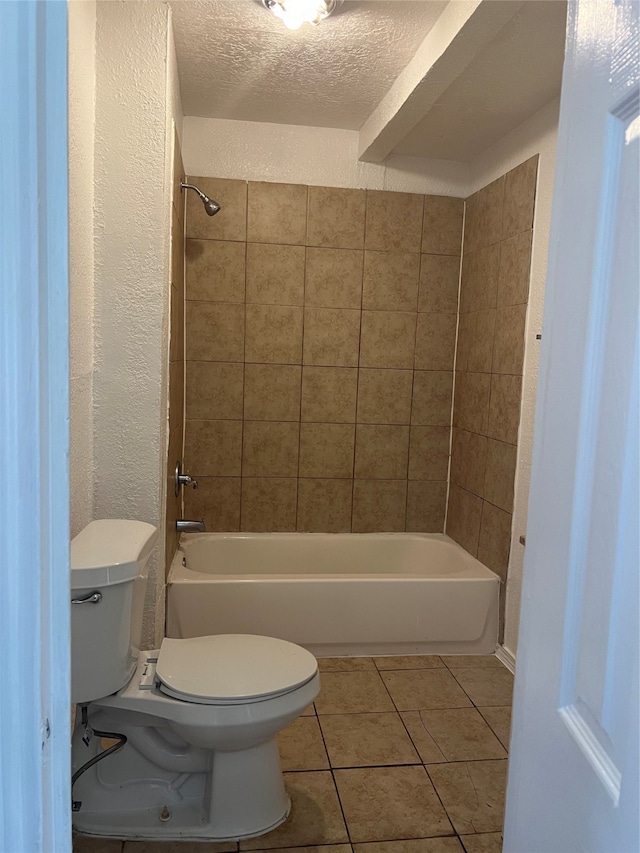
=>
[182,116,469,196]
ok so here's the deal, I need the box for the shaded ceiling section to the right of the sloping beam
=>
[394,0,567,160]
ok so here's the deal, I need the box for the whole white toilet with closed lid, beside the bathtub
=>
[71,520,320,841]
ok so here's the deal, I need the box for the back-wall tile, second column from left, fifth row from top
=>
[242,421,300,477]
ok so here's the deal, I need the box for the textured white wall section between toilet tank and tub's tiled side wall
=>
[93,0,171,645]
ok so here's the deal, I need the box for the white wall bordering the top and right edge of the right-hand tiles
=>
[469,99,560,656]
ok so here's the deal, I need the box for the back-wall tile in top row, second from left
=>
[247,181,307,246]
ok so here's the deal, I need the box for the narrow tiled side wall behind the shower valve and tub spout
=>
[165,136,184,572]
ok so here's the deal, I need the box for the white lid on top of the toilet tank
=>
[71,518,158,590]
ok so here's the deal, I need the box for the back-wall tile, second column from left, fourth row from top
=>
[244,364,302,421]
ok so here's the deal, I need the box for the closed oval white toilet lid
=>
[156,634,318,705]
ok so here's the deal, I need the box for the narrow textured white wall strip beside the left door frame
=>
[68,0,96,536]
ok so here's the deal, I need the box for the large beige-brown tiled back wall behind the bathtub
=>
[185,177,464,532]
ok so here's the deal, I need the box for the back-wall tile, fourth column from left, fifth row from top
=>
[355,424,409,480]
